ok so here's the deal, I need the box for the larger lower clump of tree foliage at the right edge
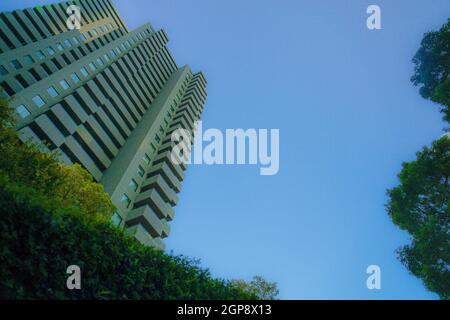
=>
[387,136,450,299]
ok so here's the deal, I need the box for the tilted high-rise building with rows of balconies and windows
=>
[0,0,206,248]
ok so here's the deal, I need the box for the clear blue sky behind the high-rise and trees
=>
[0,0,450,299]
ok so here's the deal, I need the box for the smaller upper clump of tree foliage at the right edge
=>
[411,19,450,122]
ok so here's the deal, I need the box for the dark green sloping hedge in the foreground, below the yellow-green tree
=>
[0,175,256,299]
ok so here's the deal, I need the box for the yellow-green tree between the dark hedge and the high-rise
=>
[0,100,115,218]
